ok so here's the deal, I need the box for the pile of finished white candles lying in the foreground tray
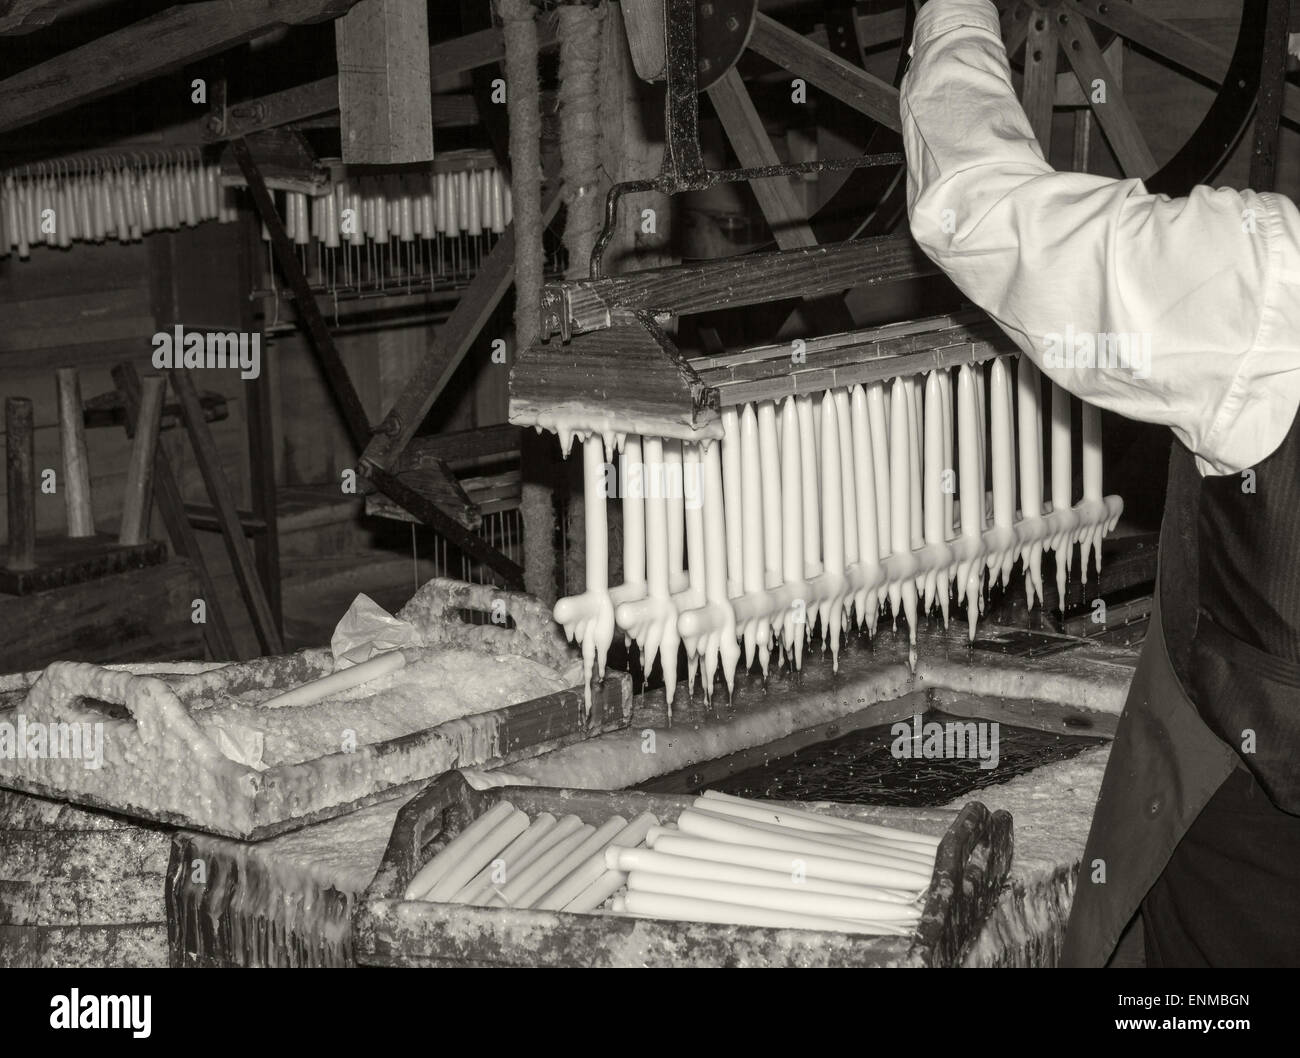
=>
[406,792,939,936]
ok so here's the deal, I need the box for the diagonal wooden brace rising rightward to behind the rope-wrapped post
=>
[361,175,560,473]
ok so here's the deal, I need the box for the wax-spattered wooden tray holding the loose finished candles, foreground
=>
[352,772,1013,967]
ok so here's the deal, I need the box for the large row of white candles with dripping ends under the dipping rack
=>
[555,357,1122,708]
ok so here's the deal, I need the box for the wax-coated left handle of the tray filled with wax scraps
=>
[25,662,230,763]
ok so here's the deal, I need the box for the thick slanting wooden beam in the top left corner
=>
[0,0,358,133]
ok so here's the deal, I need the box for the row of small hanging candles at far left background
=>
[0,160,238,260]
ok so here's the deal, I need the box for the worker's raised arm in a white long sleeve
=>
[902,0,1300,473]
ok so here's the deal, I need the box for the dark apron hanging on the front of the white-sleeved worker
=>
[1061,439,1240,966]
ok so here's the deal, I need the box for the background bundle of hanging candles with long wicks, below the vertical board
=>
[263,159,514,287]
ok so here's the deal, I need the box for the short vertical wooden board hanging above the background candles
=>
[334,0,433,165]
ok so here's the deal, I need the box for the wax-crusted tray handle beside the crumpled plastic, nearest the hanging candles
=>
[397,577,577,668]
